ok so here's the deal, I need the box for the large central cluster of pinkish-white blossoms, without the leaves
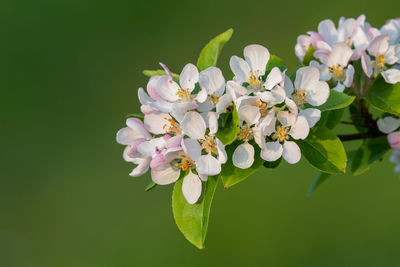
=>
[117,45,329,204]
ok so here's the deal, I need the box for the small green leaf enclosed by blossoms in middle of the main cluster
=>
[215,105,240,145]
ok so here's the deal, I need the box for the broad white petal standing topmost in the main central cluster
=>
[243,45,270,76]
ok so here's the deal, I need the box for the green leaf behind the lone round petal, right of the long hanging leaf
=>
[221,140,264,188]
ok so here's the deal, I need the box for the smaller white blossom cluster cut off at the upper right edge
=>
[295,15,400,92]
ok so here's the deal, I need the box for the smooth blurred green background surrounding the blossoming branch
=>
[0,0,400,267]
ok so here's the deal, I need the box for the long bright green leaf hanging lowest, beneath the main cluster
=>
[172,175,218,249]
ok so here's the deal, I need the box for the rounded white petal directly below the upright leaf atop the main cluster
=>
[199,67,225,96]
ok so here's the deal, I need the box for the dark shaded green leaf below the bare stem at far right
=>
[351,136,390,175]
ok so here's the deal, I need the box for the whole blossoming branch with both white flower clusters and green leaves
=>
[117,15,400,248]
